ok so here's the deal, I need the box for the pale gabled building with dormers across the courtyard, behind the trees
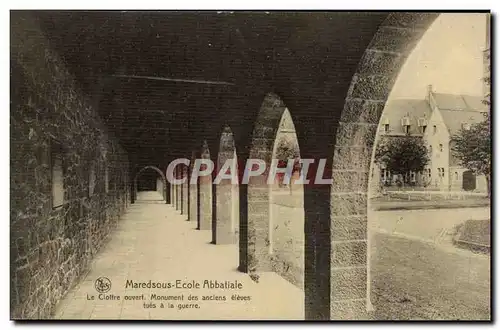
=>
[372,85,488,192]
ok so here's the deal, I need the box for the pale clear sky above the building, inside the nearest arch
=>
[389,13,486,99]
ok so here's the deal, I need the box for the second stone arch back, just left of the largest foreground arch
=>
[243,93,286,273]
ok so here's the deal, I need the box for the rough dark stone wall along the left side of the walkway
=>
[10,18,130,319]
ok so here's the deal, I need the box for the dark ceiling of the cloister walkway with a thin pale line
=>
[23,11,387,168]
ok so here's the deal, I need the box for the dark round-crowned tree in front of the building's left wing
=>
[375,136,429,182]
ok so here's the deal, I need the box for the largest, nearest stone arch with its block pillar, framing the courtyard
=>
[328,12,439,319]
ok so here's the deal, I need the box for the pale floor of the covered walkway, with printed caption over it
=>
[55,192,304,320]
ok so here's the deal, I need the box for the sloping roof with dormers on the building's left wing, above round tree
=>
[380,99,431,135]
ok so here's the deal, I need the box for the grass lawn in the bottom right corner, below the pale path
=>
[370,234,491,320]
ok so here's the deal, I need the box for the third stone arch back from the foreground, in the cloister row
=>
[212,126,239,244]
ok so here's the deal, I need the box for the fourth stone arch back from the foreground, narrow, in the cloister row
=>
[198,140,212,230]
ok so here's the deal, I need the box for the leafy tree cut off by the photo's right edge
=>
[451,50,491,196]
